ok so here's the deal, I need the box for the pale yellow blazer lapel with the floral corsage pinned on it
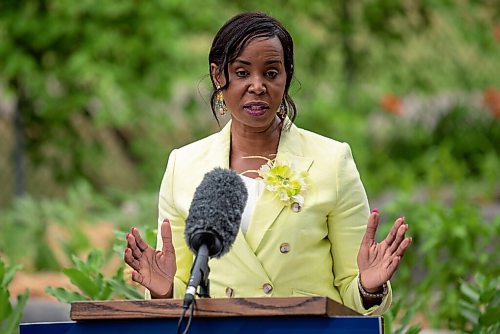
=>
[245,124,313,252]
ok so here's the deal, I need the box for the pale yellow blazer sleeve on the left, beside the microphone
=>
[156,150,193,298]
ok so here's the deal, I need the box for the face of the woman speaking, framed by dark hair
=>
[212,37,286,130]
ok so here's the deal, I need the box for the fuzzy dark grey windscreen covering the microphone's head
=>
[185,168,248,257]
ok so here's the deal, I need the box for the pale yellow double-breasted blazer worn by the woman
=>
[157,122,391,314]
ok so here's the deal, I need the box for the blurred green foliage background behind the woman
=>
[0,0,500,330]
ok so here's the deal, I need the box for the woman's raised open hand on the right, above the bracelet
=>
[358,211,412,293]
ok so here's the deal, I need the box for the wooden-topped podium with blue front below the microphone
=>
[20,297,383,334]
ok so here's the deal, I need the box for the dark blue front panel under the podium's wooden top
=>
[20,316,383,334]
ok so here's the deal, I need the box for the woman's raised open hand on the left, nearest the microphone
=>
[125,219,177,298]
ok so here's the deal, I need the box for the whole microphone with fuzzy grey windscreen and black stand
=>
[183,168,248,309]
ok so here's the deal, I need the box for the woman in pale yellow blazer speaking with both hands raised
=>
[125,13,411,314]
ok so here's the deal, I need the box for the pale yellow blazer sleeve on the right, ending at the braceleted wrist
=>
[328,143,392,315]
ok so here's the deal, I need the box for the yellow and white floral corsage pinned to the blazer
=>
[244,157,307,212]
